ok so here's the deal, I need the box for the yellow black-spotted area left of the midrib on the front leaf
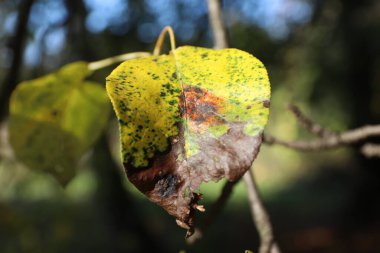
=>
[107,56,181,167]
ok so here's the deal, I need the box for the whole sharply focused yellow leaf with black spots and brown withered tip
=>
[106,46,270,234]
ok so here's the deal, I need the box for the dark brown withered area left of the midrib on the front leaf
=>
[124,134,199,231]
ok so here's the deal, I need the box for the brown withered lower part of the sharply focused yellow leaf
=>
[125,124,262,236]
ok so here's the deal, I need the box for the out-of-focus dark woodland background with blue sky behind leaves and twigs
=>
[0,0,380,253]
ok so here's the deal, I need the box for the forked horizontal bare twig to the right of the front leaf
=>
[264,106,380,157]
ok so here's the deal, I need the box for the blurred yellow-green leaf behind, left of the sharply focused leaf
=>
[9,62,110,185]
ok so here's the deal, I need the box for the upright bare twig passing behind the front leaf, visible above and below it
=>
[208,0,280,253]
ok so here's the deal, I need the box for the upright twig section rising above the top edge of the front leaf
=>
[207,0,228,49]
